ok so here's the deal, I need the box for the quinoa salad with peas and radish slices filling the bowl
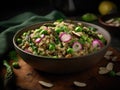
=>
[16,20,107,58]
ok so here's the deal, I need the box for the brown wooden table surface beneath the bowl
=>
[0,47,120,90]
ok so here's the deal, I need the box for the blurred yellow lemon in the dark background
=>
[98,0,117,15]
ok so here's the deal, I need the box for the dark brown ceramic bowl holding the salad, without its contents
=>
[13,21,111,74]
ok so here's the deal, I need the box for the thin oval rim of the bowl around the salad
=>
[12,20,111,60]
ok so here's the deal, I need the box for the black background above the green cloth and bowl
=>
[0,0,120,20]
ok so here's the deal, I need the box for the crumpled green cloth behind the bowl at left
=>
[0,11,66,56]
